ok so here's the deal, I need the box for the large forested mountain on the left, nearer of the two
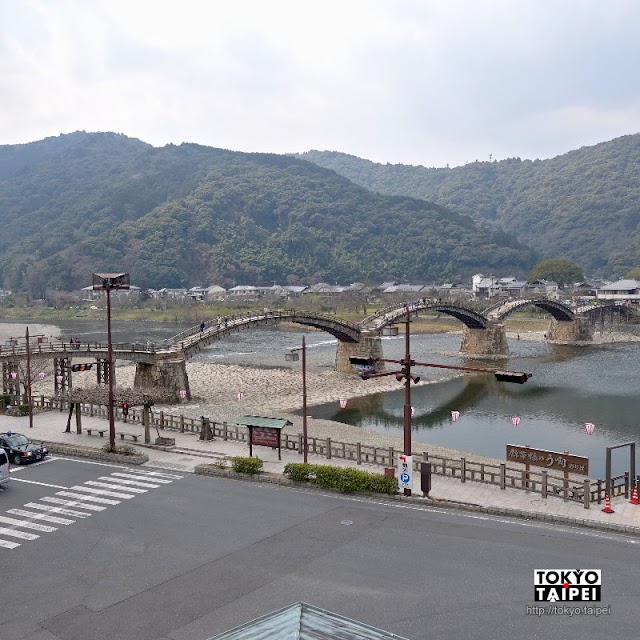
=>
[0,132,536,296]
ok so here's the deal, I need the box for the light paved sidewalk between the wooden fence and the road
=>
[5,411,640,536]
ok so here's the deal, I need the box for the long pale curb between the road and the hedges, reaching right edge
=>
[194,465,640,538]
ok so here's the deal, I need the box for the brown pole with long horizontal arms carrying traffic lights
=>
[349,305,531,496]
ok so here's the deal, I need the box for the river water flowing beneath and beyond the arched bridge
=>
[6,319,640,477]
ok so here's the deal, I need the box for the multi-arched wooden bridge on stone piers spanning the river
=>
[0,298,629,395]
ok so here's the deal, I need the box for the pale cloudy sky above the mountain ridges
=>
[0,0,640,167]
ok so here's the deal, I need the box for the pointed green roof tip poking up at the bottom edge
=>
[209,602,407,640]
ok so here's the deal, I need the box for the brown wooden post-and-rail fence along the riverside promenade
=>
[28,396,640,509]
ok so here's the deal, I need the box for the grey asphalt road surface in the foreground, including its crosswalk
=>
[0,459,640,640]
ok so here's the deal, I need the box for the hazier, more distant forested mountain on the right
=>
[297,134,640,277]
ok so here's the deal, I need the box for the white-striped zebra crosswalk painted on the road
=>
[0,470,183,549]
